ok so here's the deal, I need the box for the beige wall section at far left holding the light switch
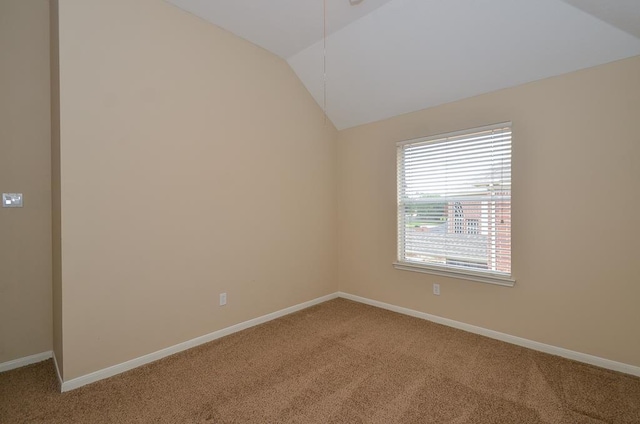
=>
[0,0,51,363]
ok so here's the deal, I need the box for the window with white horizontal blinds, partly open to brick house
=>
[394,123,515,286]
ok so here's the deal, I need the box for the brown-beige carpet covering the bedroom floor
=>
[0,299,640,424]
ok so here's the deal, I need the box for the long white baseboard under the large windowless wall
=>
[60,293,338,392]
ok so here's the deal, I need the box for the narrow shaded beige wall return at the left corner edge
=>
[49,0,64,379]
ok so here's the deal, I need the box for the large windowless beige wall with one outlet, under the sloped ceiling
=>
[58,0,337,380]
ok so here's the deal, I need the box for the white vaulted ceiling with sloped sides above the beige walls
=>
[168,0,640,129]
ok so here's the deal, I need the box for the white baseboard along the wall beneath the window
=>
[338,292,640,377]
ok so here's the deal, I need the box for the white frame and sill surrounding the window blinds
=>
[393,122,515,287]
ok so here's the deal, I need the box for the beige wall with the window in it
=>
[338,57,640,366]
